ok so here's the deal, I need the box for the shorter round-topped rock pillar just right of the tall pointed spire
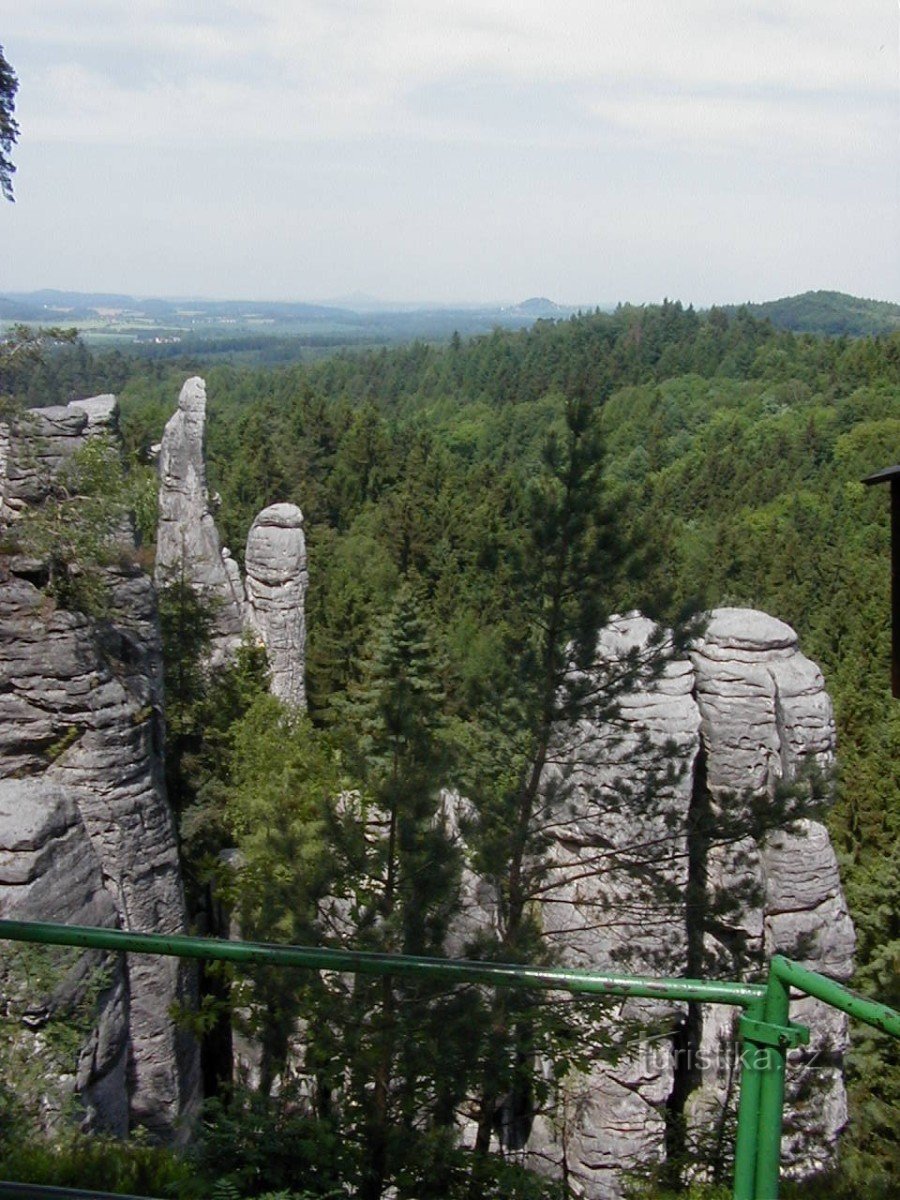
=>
[244,504,307,708]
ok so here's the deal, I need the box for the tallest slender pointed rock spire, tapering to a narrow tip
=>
[156,376,245,661]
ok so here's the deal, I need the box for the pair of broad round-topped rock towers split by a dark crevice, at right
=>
[518,608,853,1200]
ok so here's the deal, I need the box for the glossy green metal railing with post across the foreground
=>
[0,920,900,1200]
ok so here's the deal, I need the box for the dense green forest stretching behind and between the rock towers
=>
[0,301,900,1200]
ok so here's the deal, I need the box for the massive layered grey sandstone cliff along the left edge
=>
[0,397,198,1136]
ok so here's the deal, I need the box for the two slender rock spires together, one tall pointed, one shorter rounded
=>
[156,377,307,708]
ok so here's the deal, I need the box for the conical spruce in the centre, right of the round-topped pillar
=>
[335,583,460,1200]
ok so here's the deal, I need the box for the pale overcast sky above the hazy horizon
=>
[0,0,900,305]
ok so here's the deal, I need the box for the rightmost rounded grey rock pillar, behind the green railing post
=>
[691,608,854,1174]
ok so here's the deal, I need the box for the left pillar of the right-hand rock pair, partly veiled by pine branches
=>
[520,617,700,1196]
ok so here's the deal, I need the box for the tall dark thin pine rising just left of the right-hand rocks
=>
[466,397,676,1156]
